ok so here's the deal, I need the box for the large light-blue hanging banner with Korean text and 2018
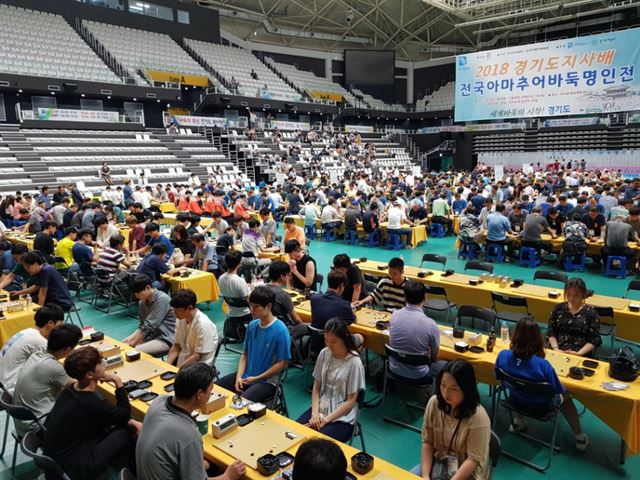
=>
[455,28,640,122]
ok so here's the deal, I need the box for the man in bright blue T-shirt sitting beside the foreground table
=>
[216,286,291,406]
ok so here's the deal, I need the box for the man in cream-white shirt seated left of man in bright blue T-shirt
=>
[167,289,218,368]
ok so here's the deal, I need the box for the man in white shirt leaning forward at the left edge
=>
[0,303,64,394]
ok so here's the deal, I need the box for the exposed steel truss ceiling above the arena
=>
[182,0,640,62]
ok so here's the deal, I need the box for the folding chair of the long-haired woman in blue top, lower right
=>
[492,369,560,472]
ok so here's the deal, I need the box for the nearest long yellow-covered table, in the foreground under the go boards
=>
[92,337,419,480]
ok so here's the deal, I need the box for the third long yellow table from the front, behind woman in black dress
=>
[358,260,640,342]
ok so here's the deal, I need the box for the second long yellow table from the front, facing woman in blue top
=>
[293,297,640,455]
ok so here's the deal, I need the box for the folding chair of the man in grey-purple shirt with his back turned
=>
[381,344,435,432]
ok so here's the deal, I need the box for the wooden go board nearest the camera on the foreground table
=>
[209,416,305,469]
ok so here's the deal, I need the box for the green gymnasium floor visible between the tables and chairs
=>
[0,232,640,480]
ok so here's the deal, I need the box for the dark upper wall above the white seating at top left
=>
[0,0,220,43]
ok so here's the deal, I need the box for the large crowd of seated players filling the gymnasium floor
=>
[0,131,640,480]
